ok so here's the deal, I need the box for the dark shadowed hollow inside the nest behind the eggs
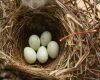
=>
[13,13,65,65]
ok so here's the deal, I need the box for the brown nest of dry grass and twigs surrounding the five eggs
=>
[0,1,100,80]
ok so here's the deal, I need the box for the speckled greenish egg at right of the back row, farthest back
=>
[40,31,52,46]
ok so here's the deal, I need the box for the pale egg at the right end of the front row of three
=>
[47,41,59,59]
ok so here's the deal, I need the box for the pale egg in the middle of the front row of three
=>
[37,46,48,63]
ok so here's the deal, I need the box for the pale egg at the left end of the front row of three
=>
[24,47,36,64]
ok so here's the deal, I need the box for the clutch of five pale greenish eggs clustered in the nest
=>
[24,31,59,64]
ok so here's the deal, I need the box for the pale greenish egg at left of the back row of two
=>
[29,35,40,50]
